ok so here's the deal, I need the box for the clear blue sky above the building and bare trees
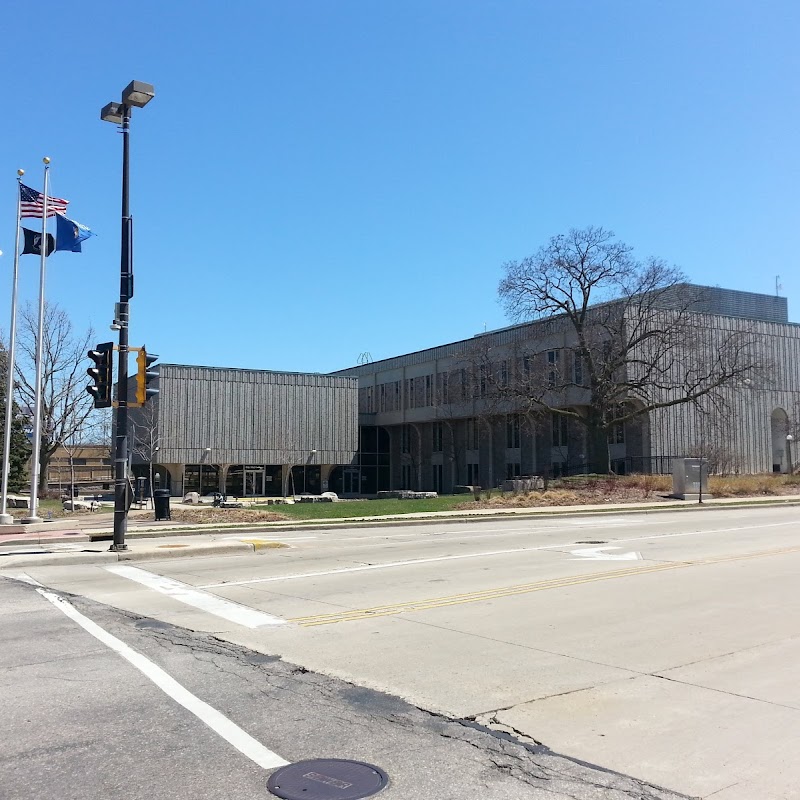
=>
[0,0,800,372]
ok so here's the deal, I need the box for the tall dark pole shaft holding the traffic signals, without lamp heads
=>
[109,104,133,551]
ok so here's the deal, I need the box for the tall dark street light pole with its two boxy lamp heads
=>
[100,81,155,551]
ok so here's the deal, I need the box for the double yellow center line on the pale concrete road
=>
[288,547,800,628]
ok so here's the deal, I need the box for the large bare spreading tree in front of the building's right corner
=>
[499,227,764,471]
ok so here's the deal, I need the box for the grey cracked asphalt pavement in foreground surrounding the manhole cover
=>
[0,578,677,800]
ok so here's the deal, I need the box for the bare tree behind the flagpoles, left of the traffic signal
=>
[15,303,94,491]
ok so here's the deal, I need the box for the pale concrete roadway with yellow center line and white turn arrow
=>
[6,508,800,800]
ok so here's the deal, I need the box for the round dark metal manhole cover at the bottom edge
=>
[267,758,389,800]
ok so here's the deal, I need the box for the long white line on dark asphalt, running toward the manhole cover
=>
[36,589,289,769]
